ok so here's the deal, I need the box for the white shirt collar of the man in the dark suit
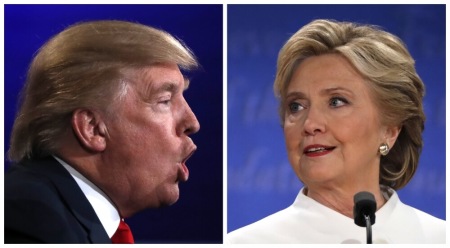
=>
[53,156,120,238]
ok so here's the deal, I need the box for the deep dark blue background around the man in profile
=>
[4,5,223,243]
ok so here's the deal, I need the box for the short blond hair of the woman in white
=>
[274,20,425,189]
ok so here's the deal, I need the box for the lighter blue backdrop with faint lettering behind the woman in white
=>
[227,5,446,232]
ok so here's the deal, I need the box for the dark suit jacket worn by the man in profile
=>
[5,157,111,243]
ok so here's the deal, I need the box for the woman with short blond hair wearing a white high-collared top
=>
[226,20,445,243]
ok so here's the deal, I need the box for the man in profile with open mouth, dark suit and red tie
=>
[5,21,200,243]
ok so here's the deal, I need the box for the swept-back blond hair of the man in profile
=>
[8,20,198,161]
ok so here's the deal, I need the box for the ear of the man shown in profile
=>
[72,109,107,152]
